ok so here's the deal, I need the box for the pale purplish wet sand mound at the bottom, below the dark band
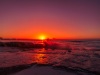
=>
[12,65,95,75]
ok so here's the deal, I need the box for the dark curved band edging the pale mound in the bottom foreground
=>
[0,63,100,75]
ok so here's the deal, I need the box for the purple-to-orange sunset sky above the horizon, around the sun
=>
[0,0,100,39]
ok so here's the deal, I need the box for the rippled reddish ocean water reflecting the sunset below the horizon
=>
[0,40,100,75]
